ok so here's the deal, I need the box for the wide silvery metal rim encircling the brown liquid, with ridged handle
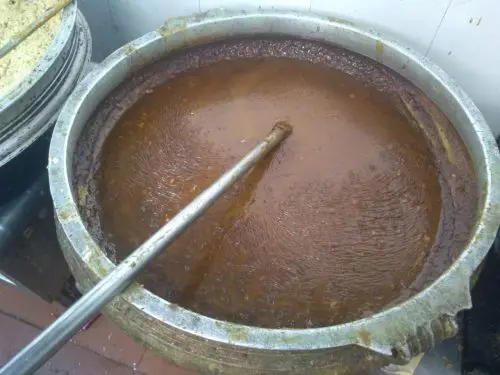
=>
[49,9,500,360]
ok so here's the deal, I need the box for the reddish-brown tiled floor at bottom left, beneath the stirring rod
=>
[0,282,196,375]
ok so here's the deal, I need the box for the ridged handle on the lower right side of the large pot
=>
[392,315,458,362]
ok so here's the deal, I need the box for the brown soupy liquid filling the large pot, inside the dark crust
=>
[99,59,441,327]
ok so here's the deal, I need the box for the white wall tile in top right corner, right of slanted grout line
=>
[428,0,500,135]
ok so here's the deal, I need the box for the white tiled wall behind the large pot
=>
[80,0,500,135]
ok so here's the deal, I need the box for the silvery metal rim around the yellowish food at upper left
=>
[0,1,86,166]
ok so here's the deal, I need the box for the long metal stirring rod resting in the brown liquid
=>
[0,122,292,375]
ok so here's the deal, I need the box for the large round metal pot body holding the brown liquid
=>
[49,10,500,374]
